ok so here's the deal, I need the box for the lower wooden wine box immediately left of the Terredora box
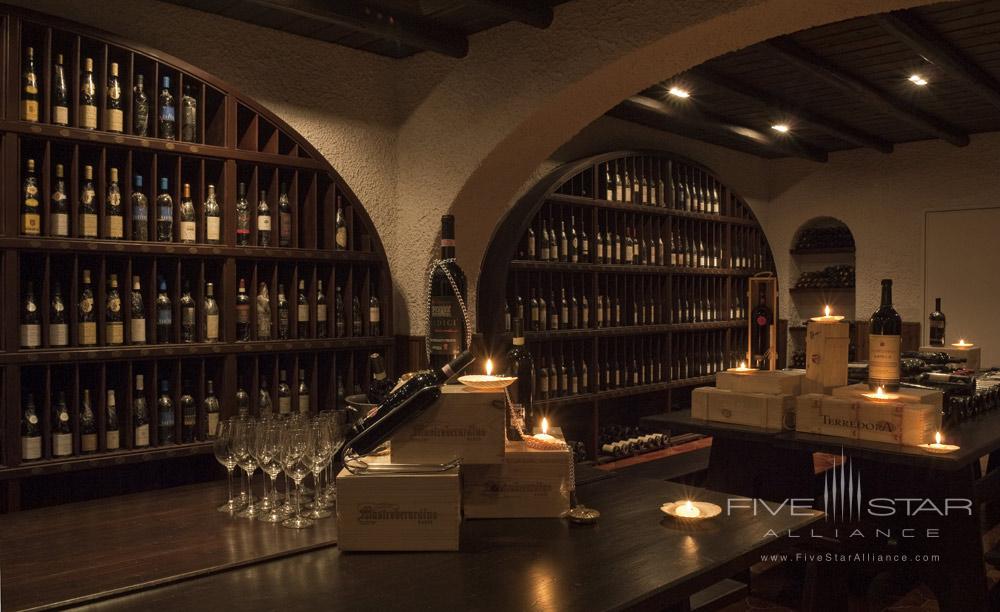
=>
[691,387,795,431]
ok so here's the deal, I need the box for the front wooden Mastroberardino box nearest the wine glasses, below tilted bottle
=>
[337,457,462,551]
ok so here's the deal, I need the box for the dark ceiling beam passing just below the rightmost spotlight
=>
[760,38,969,147]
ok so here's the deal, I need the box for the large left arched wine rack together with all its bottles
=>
[0,6,392,509]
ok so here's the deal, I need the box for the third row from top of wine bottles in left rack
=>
[20,269,382,349]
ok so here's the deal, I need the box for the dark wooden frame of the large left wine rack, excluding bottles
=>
[0,6,392,502]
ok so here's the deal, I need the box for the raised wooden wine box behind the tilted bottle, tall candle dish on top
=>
[391,385,506,464]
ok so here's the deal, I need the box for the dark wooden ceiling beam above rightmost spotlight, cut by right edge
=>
[875,11,1000,107]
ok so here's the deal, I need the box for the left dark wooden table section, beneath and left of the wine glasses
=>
[0,476,337,611]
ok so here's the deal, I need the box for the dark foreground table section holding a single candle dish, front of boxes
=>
[72,476,822,611]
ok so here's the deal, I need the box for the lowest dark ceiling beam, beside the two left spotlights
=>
[608,95,827,162]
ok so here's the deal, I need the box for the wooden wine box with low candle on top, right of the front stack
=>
[462,432,572,519]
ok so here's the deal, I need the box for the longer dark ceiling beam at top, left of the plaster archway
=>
[244,0,469,58]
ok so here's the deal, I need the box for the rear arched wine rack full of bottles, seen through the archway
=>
[477,151,774,458]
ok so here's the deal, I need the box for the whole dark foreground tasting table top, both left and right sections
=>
[0,470,823,611]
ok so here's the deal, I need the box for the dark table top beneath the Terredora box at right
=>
[642,410,1000,470]
